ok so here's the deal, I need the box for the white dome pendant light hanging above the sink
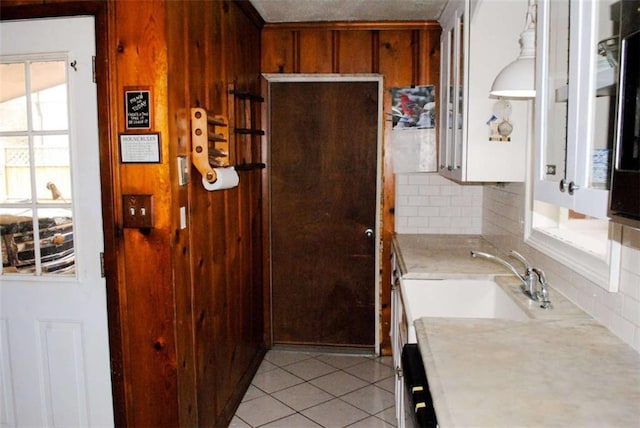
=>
[490,0,536,98]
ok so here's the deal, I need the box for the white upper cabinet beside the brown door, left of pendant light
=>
[438,0,531,182]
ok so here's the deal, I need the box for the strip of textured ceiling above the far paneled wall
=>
[250,0,447,23]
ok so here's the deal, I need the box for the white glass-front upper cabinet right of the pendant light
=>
[534,0,618,219]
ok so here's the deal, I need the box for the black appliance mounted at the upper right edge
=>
[609,0,640,228]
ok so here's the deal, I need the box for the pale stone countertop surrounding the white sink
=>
[394,235,640,427]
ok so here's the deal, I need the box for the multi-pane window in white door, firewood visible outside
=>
[0,56,75,276]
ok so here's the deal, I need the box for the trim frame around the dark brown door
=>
[262,73,384,352]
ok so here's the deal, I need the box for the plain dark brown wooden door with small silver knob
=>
[269,81,379,347]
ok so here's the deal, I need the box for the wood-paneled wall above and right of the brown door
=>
[261,22,440,355]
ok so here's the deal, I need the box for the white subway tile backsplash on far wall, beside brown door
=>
[395,173,483,234]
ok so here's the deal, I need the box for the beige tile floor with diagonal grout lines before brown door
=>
[230,350,396,428]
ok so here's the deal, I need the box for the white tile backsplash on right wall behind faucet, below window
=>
[482,183,640,352]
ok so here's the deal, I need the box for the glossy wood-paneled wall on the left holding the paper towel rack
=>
[0,0,265,427]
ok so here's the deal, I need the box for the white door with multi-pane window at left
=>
[0,17,114,427]
